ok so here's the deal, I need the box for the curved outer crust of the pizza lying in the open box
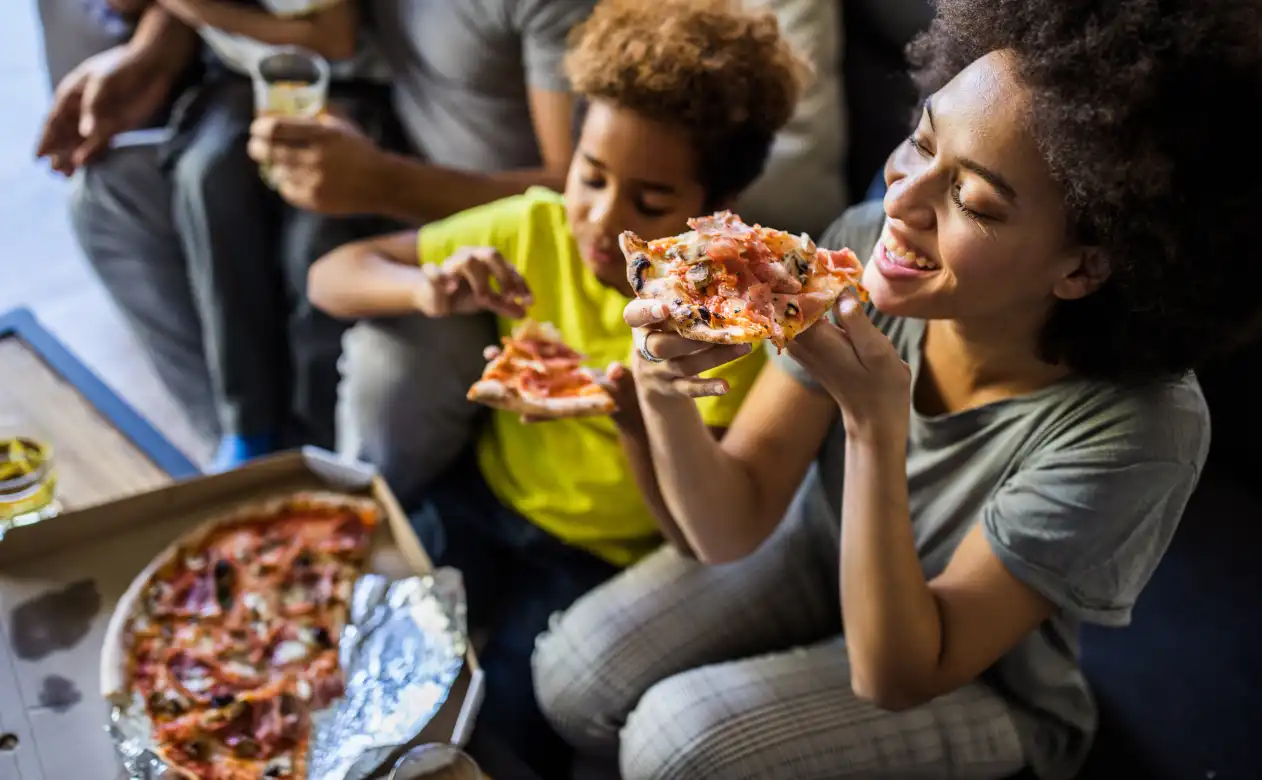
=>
[101,491,381,707]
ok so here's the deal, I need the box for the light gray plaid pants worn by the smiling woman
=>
[534,482,1025,780]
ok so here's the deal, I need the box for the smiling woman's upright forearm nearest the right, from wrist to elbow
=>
[839,435,943,709]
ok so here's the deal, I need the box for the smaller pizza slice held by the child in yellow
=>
[468,319,617,419]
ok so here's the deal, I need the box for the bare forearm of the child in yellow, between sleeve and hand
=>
[307,230,428,319]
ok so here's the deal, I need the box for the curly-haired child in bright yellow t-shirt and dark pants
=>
[308,0,803,777]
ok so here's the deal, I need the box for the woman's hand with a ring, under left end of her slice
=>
[622,299,752,398]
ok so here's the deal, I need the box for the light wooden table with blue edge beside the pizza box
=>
[0,309,198,510]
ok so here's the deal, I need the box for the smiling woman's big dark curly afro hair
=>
[909,0,1262,379]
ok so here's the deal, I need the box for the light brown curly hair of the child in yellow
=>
[565,0,809,206]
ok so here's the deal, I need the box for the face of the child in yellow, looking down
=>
[565,101,705,298]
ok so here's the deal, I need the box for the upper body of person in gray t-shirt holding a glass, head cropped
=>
[251,0,596,223]
